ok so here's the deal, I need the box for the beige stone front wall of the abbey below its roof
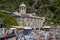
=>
[17,17,44,28]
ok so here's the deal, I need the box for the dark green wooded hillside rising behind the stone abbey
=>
[0,0,60,27]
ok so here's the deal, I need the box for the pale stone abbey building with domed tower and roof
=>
[14,3,45,28]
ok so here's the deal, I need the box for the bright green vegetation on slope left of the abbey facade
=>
[0,11,18,28]
